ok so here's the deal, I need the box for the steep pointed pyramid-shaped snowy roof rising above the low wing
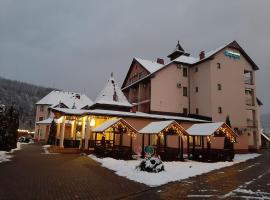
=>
[94,75,132,107]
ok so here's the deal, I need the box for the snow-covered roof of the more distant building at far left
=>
[36,90,93,109]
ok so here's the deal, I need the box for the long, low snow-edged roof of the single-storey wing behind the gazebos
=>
[53,108,209,122]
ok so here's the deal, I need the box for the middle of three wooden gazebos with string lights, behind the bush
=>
[139,120,187,160]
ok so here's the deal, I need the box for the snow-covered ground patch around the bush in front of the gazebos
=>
[89,153,260,187]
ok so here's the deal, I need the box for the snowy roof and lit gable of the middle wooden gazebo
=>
[139,120,187,135]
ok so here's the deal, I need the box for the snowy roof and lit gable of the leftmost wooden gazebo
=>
[93,118,138,134]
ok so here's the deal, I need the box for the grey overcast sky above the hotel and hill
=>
[0,0,270,113]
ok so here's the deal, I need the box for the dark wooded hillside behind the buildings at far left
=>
[0,77,53,130]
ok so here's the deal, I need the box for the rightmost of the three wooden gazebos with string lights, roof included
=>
[187,122,238,161]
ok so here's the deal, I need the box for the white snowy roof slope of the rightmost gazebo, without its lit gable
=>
[186,122,225,136]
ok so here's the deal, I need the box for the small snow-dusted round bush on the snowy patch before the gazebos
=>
[136,157,164,173]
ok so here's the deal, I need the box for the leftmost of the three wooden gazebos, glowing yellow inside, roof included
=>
[92,118,137,159]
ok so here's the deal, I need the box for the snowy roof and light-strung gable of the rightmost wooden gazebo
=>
[187,122,238,142]
